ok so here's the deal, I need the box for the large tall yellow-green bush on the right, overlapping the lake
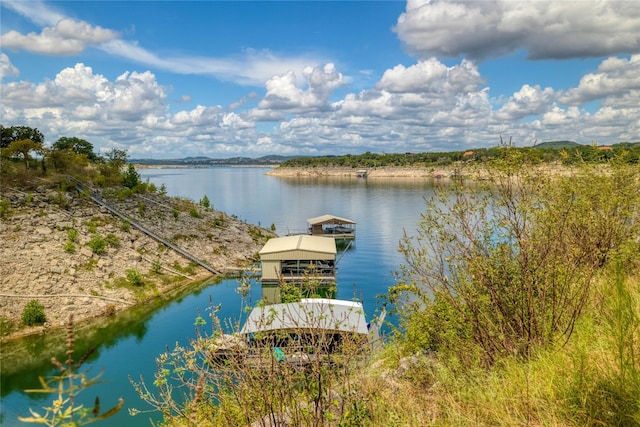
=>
[400,160,640,364]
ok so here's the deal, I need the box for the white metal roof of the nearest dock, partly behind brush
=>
[240,298,368,334]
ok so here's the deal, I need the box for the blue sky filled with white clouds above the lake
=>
[0,0,640,159]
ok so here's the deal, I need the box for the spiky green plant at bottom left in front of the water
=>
[18,318,124,427]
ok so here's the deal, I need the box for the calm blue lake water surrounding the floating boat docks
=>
[0,167,434,427]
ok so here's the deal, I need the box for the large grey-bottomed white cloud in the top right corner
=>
[395,0,640,59]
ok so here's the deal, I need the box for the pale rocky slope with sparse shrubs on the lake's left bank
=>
[0,188,273,341]
